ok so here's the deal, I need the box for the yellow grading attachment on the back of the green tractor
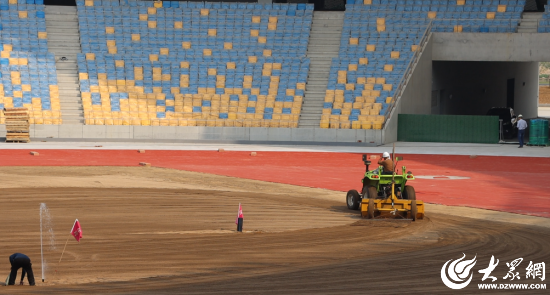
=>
[361,183,424,221]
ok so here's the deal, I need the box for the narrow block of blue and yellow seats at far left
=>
[0,0,62,124]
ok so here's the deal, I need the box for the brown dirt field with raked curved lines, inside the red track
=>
[0,167,550,294]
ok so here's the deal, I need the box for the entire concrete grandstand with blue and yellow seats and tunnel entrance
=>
[0,0,550,144]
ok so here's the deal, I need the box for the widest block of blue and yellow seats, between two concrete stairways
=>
[77,0,313,127]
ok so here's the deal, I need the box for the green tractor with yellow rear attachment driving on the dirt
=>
[346,155,424,221]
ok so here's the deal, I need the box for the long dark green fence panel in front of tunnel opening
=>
[397,114,499,143]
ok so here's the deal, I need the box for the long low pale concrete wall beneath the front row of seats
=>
[0,125,382,145]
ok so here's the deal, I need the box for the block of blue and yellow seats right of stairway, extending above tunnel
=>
[320,0,525,129]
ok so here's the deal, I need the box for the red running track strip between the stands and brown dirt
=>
[0,150,550,217]
